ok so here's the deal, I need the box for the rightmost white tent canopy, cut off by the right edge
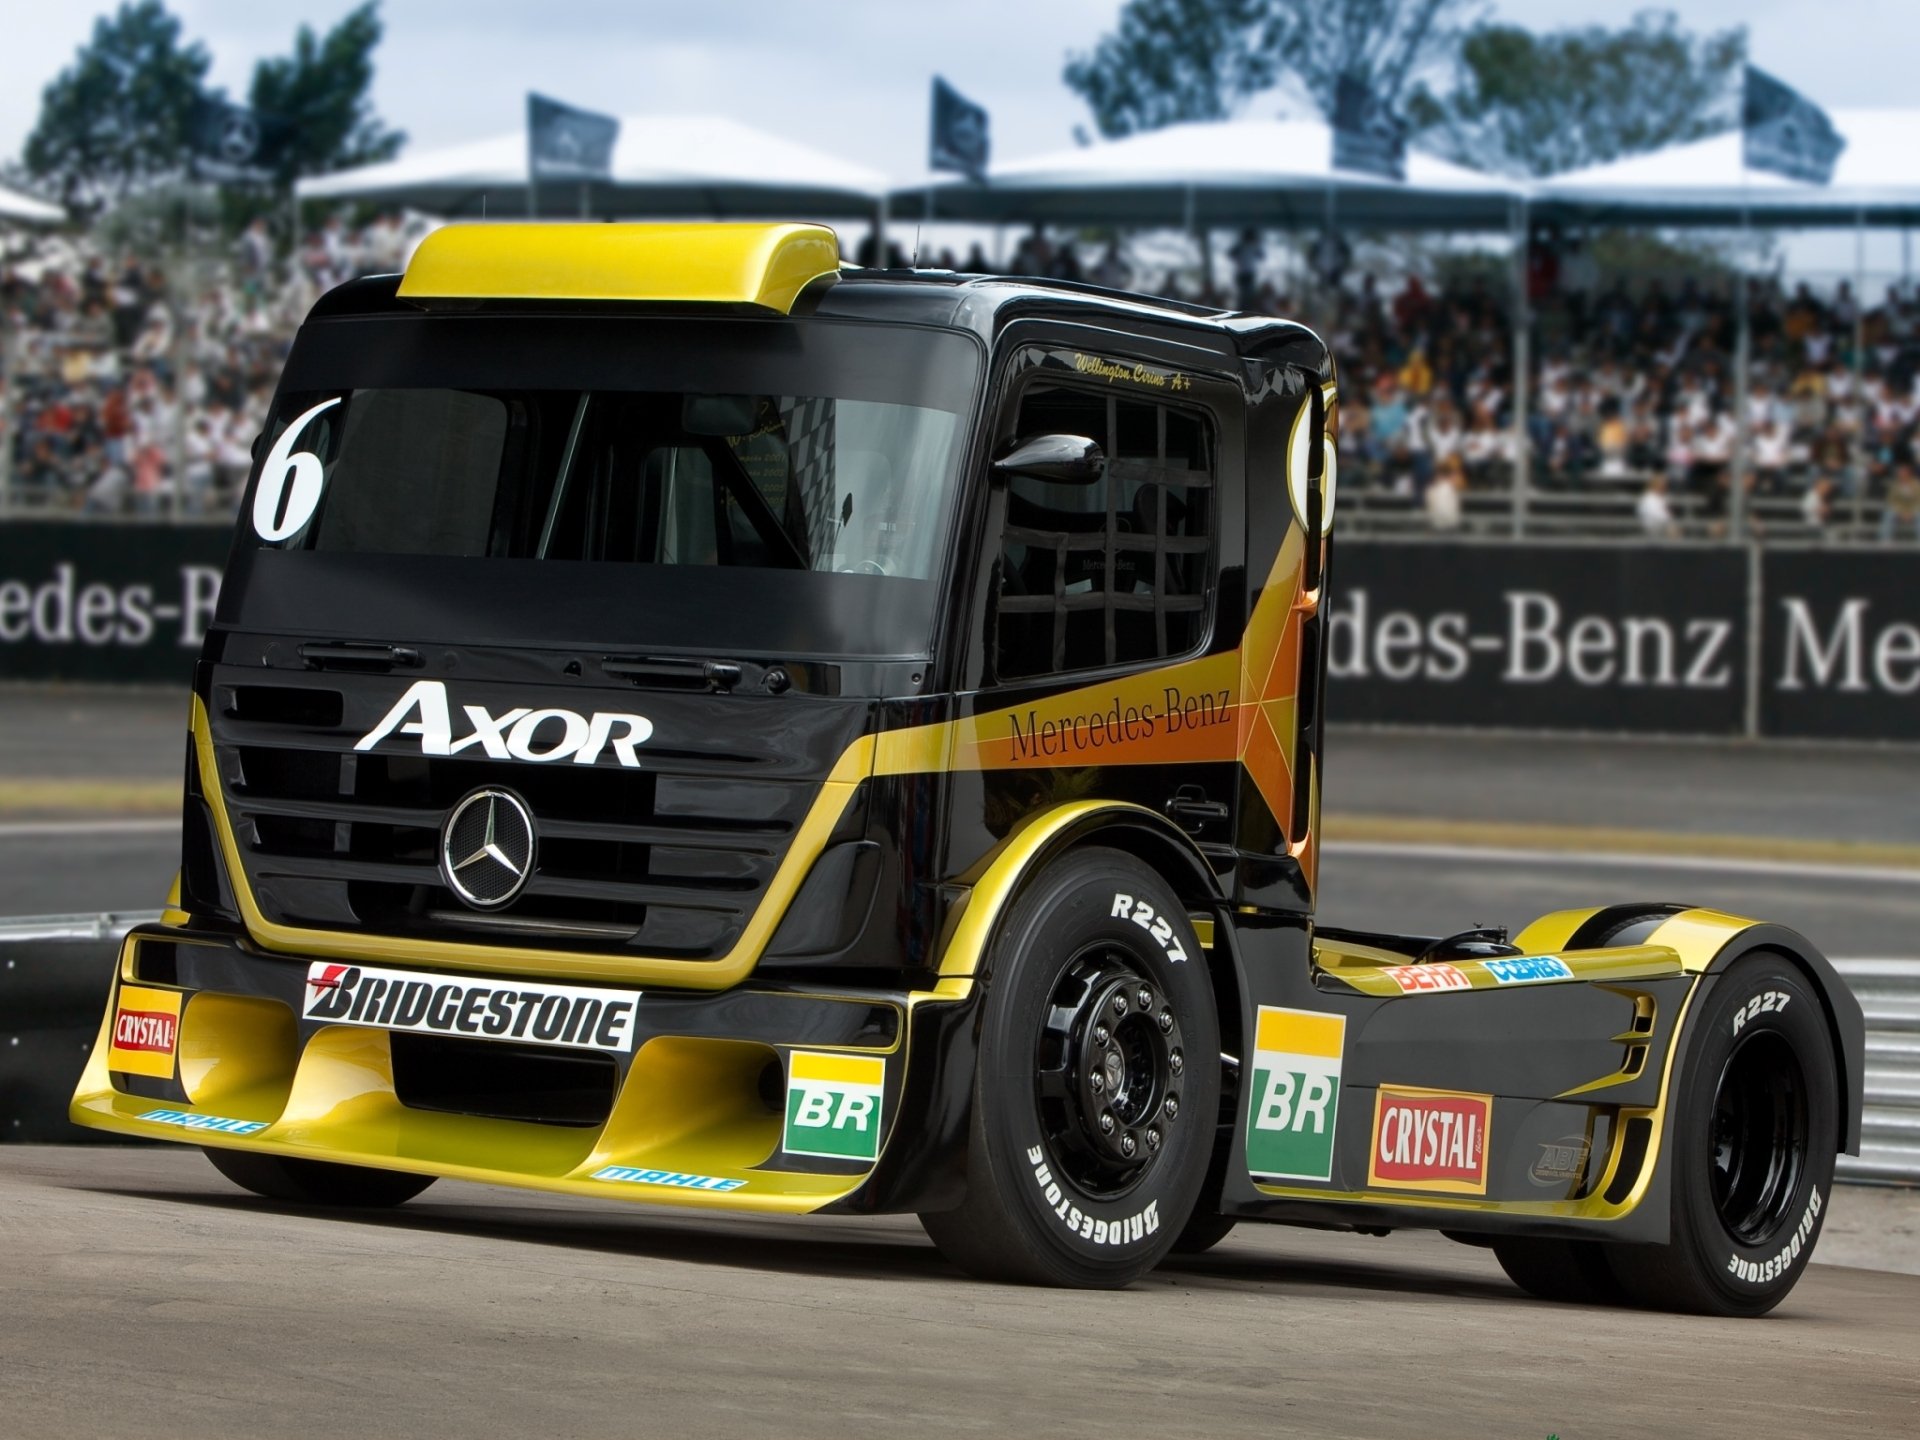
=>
[1532,109,1920,227]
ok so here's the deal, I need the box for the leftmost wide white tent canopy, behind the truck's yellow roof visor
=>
[296,115,885,219]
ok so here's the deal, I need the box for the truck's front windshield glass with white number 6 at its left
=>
[255,388,960,580]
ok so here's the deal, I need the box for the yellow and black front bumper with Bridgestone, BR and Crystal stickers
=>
[69,925,972,1213]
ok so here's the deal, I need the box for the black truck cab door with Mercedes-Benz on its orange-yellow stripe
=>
[956,332,1244,868]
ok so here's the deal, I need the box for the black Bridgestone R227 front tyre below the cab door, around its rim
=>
[977,851,1219,1265]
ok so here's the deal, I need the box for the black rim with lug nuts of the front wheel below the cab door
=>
[1035,943,1187,1200]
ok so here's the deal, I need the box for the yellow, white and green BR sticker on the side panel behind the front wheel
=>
[1246,1004,1346,1181]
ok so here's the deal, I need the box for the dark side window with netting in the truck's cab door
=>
[989,382,1215,684]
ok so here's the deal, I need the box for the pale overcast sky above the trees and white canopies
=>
[0,0,1920,180]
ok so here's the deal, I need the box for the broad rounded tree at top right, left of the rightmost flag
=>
[1407,10,1747,175]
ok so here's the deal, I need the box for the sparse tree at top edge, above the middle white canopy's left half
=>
[1066,0,1473,136]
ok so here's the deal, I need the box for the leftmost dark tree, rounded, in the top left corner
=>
[23,0,211,209]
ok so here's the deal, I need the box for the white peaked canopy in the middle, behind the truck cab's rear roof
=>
[889,119,1526,230]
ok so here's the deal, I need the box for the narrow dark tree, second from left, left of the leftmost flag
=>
[248,0,407,190]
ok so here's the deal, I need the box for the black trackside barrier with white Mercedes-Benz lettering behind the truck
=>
[0,520,1920,741]
